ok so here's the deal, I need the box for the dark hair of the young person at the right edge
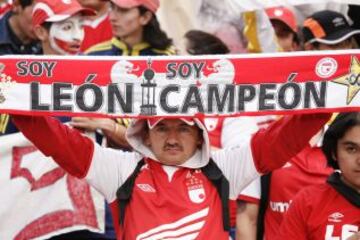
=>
[322,112,360,169]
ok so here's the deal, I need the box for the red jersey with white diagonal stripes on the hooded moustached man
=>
[111,160,229,240]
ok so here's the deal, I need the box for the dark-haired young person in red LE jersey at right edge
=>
[278,112,360,240]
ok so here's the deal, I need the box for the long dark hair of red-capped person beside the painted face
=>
[138,6,173,50]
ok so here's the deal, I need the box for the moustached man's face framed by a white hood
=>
[144,119,203,165]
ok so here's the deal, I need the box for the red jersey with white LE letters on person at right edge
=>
[277,183,360,240]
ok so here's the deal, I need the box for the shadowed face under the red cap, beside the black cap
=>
[271,20,299,52]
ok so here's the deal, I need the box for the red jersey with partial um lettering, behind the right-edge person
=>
[264,146,333,239]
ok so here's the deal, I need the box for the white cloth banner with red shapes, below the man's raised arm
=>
[0,133,105,240]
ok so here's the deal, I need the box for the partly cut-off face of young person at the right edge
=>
[336,126,360,193]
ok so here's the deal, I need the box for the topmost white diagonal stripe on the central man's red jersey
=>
[136,208,209,240]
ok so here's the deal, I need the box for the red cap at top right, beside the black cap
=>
[266,7,297,33]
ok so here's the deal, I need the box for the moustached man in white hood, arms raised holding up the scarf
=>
[13,113,330,239]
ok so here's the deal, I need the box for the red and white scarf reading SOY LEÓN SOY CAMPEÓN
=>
[0,50,360,117]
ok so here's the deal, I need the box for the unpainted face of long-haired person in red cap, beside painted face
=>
[109,3,147,39]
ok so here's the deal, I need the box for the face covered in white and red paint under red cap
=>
[50,14,84,55]
